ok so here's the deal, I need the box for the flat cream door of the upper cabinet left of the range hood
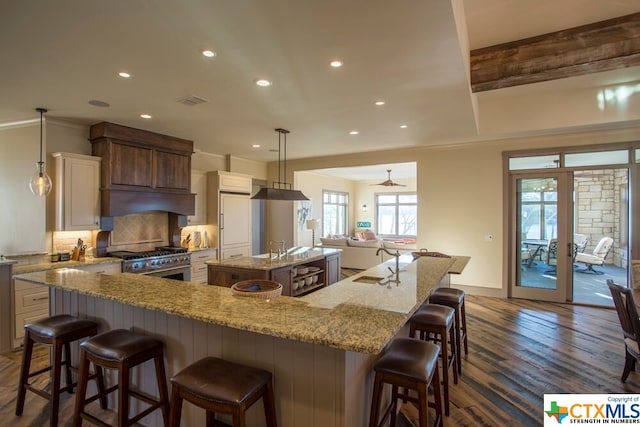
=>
[62,158,100,231]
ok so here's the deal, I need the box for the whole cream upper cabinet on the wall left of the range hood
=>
[47,153,101,231]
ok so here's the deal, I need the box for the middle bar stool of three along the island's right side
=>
[409,304,458,416]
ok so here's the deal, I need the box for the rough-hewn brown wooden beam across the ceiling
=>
[470,12,640,92]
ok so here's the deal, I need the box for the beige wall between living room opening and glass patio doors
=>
[288,127,640,295]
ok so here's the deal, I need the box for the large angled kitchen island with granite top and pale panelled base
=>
[15,257,455,427]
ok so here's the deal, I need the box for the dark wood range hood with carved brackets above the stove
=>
[89,122,195,256]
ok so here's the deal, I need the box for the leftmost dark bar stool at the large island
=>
[16,314,102,426]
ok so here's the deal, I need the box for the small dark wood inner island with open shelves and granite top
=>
[207,246,342,296]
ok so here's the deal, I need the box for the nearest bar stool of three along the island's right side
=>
[369,338,443,427]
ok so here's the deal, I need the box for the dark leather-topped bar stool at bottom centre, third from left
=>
[169,357,277,427]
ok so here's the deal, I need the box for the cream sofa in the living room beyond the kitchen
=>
[316,237,416,270]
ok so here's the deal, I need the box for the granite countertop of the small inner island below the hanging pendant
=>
[206,246,342,270]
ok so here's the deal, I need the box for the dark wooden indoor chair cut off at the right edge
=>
[607,279,640,382]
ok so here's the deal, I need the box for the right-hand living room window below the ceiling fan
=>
[376,193,418,237]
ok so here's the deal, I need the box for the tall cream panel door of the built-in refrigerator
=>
[218,193,251,247]
